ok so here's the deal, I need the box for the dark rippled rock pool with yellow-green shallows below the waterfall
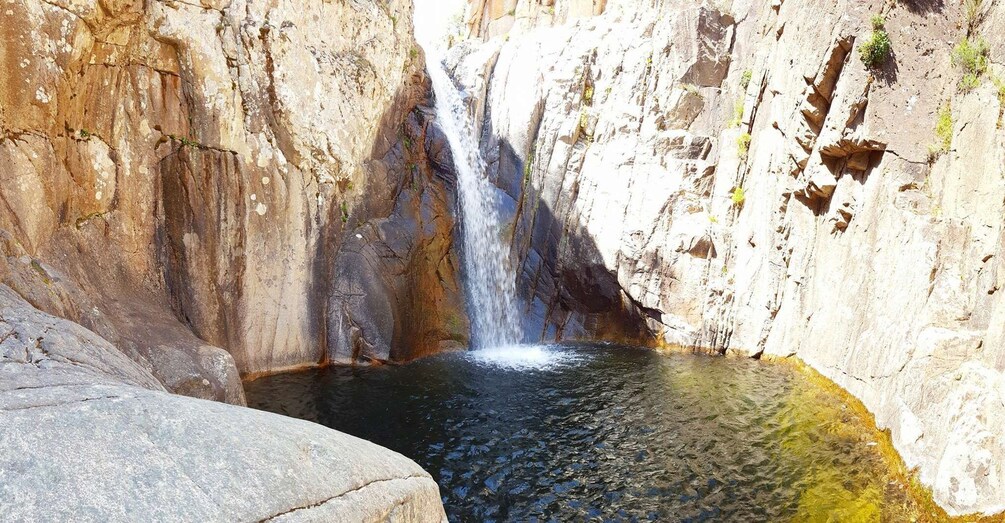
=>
[246,345,928,521]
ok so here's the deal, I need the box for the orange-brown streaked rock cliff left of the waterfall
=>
[0,0,465,394]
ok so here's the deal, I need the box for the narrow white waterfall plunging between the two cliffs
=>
[415,4,522,348]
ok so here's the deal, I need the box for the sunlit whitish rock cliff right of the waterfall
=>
[451,0,1005,514]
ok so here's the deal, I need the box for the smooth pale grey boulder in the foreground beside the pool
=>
[0,286,446,522]
